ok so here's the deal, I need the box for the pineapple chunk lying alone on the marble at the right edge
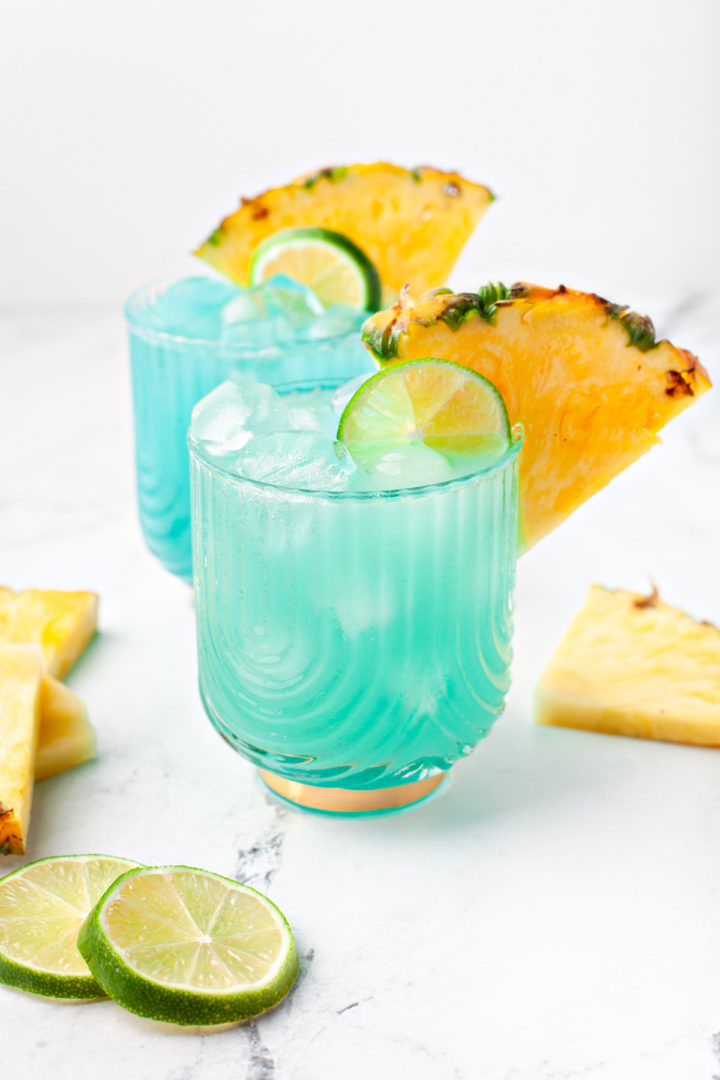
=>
[535,585,720,746]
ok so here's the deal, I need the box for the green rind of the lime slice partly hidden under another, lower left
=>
[0,854,138,1003]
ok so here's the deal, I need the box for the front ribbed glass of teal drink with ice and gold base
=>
[189,369,520,809]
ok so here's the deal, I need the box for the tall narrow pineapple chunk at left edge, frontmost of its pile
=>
[0,645,43,855]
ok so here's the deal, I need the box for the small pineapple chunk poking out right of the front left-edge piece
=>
[35,675,97,782]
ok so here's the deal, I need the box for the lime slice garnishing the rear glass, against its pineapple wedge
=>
[250,229,382,311]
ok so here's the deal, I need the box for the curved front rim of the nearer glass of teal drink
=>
[187,423,525,502]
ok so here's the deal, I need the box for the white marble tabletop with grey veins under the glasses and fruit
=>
[0,296,720,1080]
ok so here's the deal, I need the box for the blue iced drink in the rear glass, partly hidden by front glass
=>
[125,278,371,581]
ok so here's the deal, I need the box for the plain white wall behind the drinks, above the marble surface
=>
[0,0,720,309]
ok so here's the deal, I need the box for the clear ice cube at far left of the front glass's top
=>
[190,376,287,458]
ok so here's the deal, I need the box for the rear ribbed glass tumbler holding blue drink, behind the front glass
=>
[125,285,373,581]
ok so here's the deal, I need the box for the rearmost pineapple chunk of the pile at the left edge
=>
[0,588,97,678]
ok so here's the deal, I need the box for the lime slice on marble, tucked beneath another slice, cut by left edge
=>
[0,855,137,1001]
